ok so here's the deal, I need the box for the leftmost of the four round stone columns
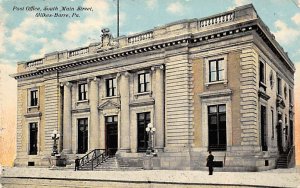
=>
[62,82,72,153]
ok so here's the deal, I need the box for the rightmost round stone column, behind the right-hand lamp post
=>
[153,65,165,151]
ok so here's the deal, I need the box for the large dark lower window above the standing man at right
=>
[208,104,227,151]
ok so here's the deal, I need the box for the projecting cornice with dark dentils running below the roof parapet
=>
[12,20,294,80]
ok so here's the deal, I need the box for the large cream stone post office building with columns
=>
[13,5,295,171]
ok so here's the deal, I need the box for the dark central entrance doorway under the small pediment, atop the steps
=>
[105,116,118,157]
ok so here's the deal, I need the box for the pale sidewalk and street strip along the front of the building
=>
[1,167,300,187]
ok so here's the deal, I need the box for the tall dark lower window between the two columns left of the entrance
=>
[78,118,88,154]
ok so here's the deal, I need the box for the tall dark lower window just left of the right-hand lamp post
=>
[137,112,150,152]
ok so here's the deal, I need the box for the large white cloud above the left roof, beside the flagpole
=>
[30,0,126,59]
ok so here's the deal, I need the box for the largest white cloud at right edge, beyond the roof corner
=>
[273,20,300,45]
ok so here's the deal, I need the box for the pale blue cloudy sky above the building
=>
[0,0,300,65]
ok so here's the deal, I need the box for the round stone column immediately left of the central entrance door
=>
[89,77,100,150]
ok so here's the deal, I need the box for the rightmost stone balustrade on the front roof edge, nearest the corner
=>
[198,12,234,28]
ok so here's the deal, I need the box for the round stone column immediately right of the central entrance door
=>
[119,72,130,152]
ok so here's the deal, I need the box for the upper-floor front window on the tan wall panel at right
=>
[209,58,225,82]
